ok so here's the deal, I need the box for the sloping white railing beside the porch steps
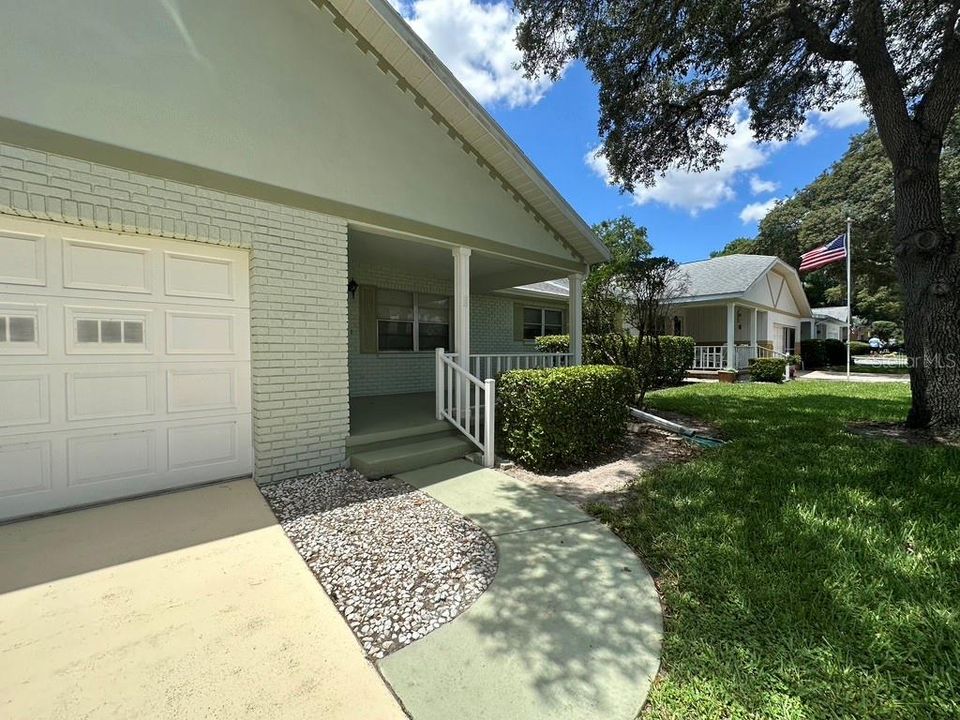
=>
[436,348,496,467]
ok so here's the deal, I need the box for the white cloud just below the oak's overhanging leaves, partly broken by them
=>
[585,108,777,215]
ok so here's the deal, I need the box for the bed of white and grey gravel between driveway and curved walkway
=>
[261,470,497,658]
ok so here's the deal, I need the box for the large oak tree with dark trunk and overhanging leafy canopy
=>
[515,0,960,427]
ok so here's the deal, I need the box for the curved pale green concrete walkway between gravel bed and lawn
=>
[379,460,662,720]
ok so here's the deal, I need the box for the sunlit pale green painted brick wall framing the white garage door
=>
[0,144,349,482]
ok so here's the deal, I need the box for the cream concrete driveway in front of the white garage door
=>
[0,480,405,720]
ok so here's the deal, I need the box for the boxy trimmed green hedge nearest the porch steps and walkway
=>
[497,365,636,472]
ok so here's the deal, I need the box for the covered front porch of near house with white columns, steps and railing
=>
[347,227,582,477]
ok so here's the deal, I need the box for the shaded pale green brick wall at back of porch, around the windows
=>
[349,259,564,397]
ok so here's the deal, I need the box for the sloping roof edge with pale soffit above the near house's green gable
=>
[330,0,610,264]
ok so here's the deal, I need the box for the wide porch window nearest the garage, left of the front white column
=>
[377,290,450,352]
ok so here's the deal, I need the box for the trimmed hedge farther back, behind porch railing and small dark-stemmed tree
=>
[536,335,696,388]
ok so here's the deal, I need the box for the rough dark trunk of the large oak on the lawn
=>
[894,148,960,429]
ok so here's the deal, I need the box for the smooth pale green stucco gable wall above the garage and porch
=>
[0,0,572,260]
